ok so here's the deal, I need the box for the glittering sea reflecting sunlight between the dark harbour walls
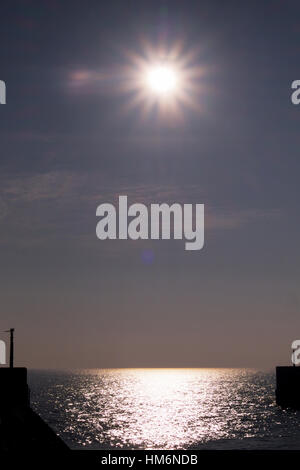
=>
[30,369,300,449]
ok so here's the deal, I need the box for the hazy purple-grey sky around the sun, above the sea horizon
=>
[0,0,300,368]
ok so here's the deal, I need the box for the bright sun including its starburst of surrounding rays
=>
[118,41,207,119]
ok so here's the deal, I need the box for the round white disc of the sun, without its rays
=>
[146,65,178,95]
